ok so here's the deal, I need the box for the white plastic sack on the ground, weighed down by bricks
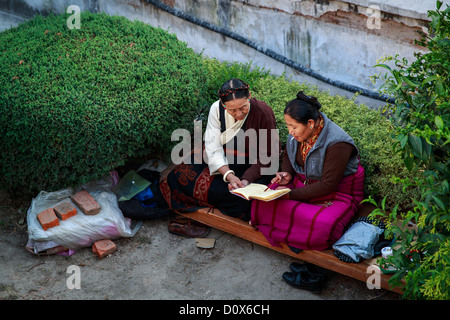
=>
[27,183,140,250]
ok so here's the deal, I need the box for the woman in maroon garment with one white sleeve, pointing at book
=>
[160,79,280,221]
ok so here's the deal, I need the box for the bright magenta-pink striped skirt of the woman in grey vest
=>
[251,165,364,250]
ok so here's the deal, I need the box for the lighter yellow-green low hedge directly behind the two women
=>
[202,59,418,209]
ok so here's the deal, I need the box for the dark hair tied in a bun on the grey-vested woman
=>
[284,91,322,125]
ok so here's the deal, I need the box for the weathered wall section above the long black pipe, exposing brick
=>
[166,0,435,88]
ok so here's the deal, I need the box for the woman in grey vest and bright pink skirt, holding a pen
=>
[251,92,364,252]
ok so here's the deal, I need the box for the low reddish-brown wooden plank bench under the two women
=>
[177,204,402,294]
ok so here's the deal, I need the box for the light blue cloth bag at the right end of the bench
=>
[333,221,384,262]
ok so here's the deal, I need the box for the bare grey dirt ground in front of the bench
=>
[0,184,400,301]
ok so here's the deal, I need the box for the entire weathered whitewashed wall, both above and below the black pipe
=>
[0,0,442,107]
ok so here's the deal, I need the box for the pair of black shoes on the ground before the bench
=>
[282,262,326,293]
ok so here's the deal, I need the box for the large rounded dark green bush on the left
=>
[0,12,206,192]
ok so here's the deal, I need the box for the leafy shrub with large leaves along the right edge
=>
[368,1,450,300]
